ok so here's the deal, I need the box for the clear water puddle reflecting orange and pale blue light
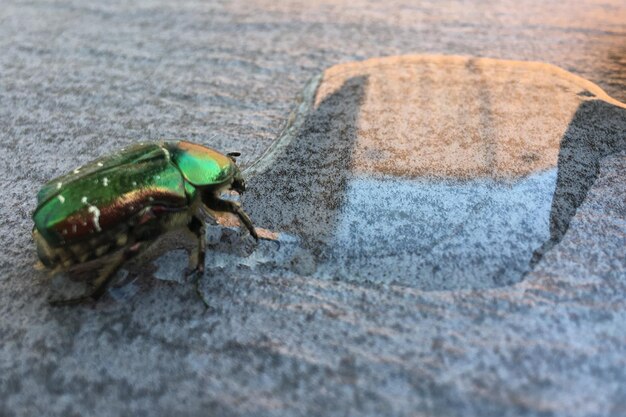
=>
[240,56,626,290]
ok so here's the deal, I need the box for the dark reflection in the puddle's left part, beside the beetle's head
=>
[245,76,367,257]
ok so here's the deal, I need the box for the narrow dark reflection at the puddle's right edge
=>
[531,98,626,267]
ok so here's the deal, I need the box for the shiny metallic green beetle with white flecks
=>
[32,141,258,305]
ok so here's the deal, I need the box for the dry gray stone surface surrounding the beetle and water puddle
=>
[0,1,626,416]
